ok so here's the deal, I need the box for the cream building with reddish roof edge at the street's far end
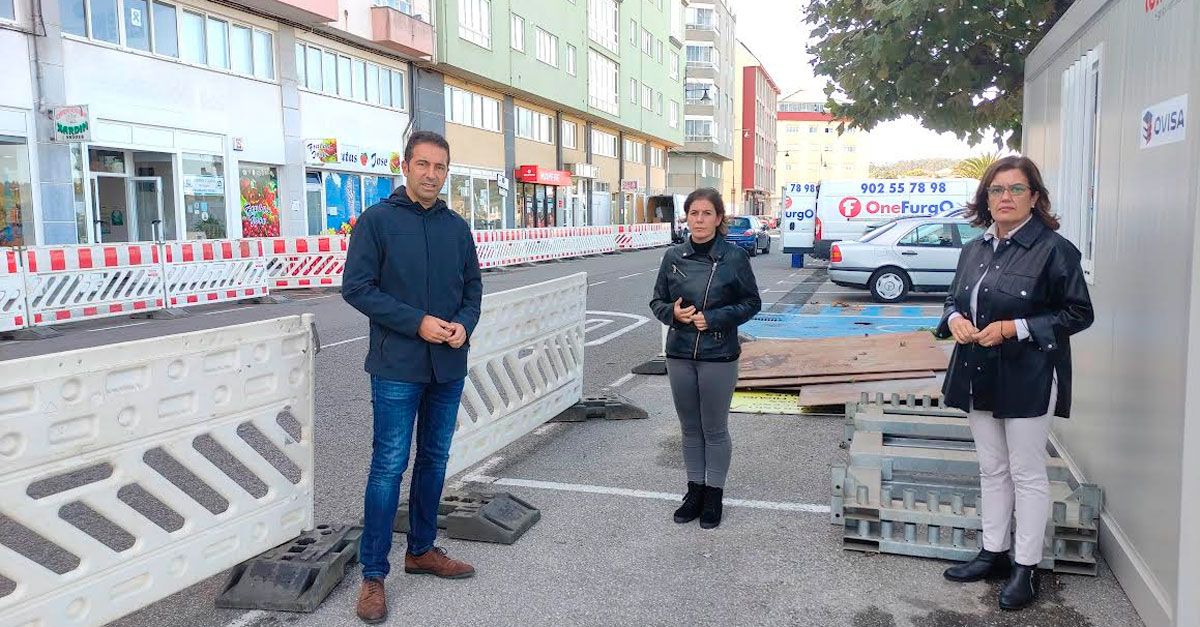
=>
[775,98,870,181]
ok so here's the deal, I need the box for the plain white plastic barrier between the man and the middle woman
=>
[446,273,588,476]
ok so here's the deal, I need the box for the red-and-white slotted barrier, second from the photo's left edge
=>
[24,243,164,326]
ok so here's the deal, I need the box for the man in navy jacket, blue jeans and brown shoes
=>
[342,131,484,623]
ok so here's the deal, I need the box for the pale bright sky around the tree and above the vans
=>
[732,0,996,163]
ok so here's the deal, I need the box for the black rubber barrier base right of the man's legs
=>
[391,492,541,544]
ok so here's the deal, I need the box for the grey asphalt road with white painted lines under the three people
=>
[0,239,1140,627]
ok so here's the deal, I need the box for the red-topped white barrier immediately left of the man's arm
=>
[264,235,350,289]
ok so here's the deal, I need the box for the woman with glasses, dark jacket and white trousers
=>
[937,156,1093,610]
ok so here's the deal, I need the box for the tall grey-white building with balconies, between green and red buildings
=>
[668,0,737,198]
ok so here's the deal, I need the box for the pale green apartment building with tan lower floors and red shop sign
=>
[416,0,683,228]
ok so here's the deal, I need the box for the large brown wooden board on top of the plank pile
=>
[739,332,949,380]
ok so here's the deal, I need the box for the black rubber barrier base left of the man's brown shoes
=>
[216,525,362,611]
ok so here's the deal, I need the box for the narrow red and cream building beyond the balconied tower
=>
[727,41,780,215]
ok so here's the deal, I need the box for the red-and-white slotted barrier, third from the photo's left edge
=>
[163,239,269,307]
